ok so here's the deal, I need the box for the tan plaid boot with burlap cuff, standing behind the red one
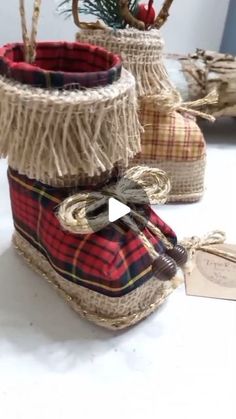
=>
[73,0,210,202]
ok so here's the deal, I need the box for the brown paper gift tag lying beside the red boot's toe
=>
[185,244,236,300]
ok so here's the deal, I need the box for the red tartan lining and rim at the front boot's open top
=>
[0,42,122,89]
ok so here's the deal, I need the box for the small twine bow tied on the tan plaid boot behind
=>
[144,89,219,122]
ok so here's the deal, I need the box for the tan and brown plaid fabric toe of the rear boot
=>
[135,101,206,163]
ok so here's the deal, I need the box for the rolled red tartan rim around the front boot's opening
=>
[0,41,122,89]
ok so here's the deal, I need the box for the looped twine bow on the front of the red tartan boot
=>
[57,166,173,260]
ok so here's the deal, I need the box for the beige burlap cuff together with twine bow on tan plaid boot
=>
[76,28,218,122]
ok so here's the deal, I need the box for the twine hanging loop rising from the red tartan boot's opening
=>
[19,0,41,64]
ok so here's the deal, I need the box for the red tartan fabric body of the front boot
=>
[8,169,176,297]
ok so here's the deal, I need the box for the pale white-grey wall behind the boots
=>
[0,0,229,53]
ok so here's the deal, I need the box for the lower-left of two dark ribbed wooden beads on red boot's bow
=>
[152,255,177,281]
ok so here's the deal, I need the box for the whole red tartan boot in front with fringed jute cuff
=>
[0,0,187,329]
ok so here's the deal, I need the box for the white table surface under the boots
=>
[0,120,236,419]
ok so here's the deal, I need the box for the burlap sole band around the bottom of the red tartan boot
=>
[13,233,183,330]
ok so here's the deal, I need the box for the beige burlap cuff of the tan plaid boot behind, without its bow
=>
[76,28,177,102]
